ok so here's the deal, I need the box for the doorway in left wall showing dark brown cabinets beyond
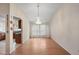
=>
[13,16,22,44]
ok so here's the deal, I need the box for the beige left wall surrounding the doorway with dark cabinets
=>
[10,4,29,52]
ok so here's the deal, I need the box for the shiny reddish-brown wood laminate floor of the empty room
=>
[11,38,69,55]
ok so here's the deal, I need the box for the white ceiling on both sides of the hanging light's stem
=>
[16,3,61,23]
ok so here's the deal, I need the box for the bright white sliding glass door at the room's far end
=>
[31,24,49,37]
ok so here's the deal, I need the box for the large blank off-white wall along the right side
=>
[50,4,79,54]
